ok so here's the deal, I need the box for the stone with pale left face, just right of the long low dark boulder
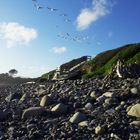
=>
[51,103,68,115]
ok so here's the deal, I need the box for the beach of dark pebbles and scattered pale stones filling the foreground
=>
[0,78,140,140]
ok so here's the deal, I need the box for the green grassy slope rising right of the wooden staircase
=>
[83,43,140,78]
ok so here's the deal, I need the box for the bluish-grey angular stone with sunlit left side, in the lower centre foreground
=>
[69,112,86,123]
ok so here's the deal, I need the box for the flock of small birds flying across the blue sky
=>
[32,0,92,44]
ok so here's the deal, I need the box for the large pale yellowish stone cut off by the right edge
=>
[127,104,140,118]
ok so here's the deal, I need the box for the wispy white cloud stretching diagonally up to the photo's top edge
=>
[76,0,114,30]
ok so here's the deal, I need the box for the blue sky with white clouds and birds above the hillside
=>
[0,0,140,77]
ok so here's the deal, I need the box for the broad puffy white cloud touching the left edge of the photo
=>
[0,22,38,48]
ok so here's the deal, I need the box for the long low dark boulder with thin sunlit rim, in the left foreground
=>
[22,107,45,119]
